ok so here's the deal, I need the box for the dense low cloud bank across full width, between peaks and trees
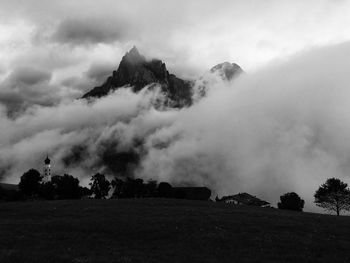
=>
[0,43,350,210]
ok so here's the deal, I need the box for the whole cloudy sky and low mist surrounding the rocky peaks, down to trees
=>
[0,0,350,214]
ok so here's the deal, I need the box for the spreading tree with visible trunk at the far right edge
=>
[314,178,350,216]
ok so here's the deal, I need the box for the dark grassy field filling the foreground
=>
[0,199,350,263]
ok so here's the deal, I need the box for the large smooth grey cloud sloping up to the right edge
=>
[139,43,350,212]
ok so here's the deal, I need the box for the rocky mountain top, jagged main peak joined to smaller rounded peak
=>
[83,46,244,108]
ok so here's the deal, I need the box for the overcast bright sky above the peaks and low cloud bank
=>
[0,0,350,83]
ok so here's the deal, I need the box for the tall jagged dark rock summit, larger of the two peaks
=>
[83,47,192,107]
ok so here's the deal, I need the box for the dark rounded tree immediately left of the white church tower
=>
[18,169,42,197]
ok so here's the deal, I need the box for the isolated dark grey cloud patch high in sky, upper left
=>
[52,18,127,45]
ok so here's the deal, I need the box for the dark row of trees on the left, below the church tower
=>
[0,169,180,201]
